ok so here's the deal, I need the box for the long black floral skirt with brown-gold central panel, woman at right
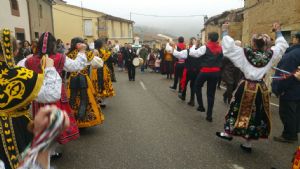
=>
[225,80,271,139]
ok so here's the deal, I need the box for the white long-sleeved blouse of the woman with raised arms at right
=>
[222,34,289,80]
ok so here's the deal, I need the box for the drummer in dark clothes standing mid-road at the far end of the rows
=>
[124,44,137,81]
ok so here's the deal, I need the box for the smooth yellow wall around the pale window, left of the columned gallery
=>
[53,4,101,43]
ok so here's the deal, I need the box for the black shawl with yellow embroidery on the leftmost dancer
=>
[0,61,44,113]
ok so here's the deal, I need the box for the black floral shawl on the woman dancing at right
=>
[244,48,273,68]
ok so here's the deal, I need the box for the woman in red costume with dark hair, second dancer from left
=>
[19,32,94,144]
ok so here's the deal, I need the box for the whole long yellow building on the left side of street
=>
[53,2,134,44]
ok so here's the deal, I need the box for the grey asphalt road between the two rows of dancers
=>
[53,70,297,169]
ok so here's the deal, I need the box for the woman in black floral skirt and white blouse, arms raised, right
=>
[216,23,288,152]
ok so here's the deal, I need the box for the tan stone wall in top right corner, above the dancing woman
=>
[243,0,300,44]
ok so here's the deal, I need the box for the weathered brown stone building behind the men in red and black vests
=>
[201,9,244,44]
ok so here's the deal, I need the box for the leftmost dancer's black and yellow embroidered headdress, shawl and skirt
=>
[0,30,44,169]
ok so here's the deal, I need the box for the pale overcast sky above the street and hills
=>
[65,0,244,36]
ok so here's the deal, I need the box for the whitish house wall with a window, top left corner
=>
[0,0,31,41]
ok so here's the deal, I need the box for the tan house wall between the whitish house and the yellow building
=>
[24,0,53,40]
